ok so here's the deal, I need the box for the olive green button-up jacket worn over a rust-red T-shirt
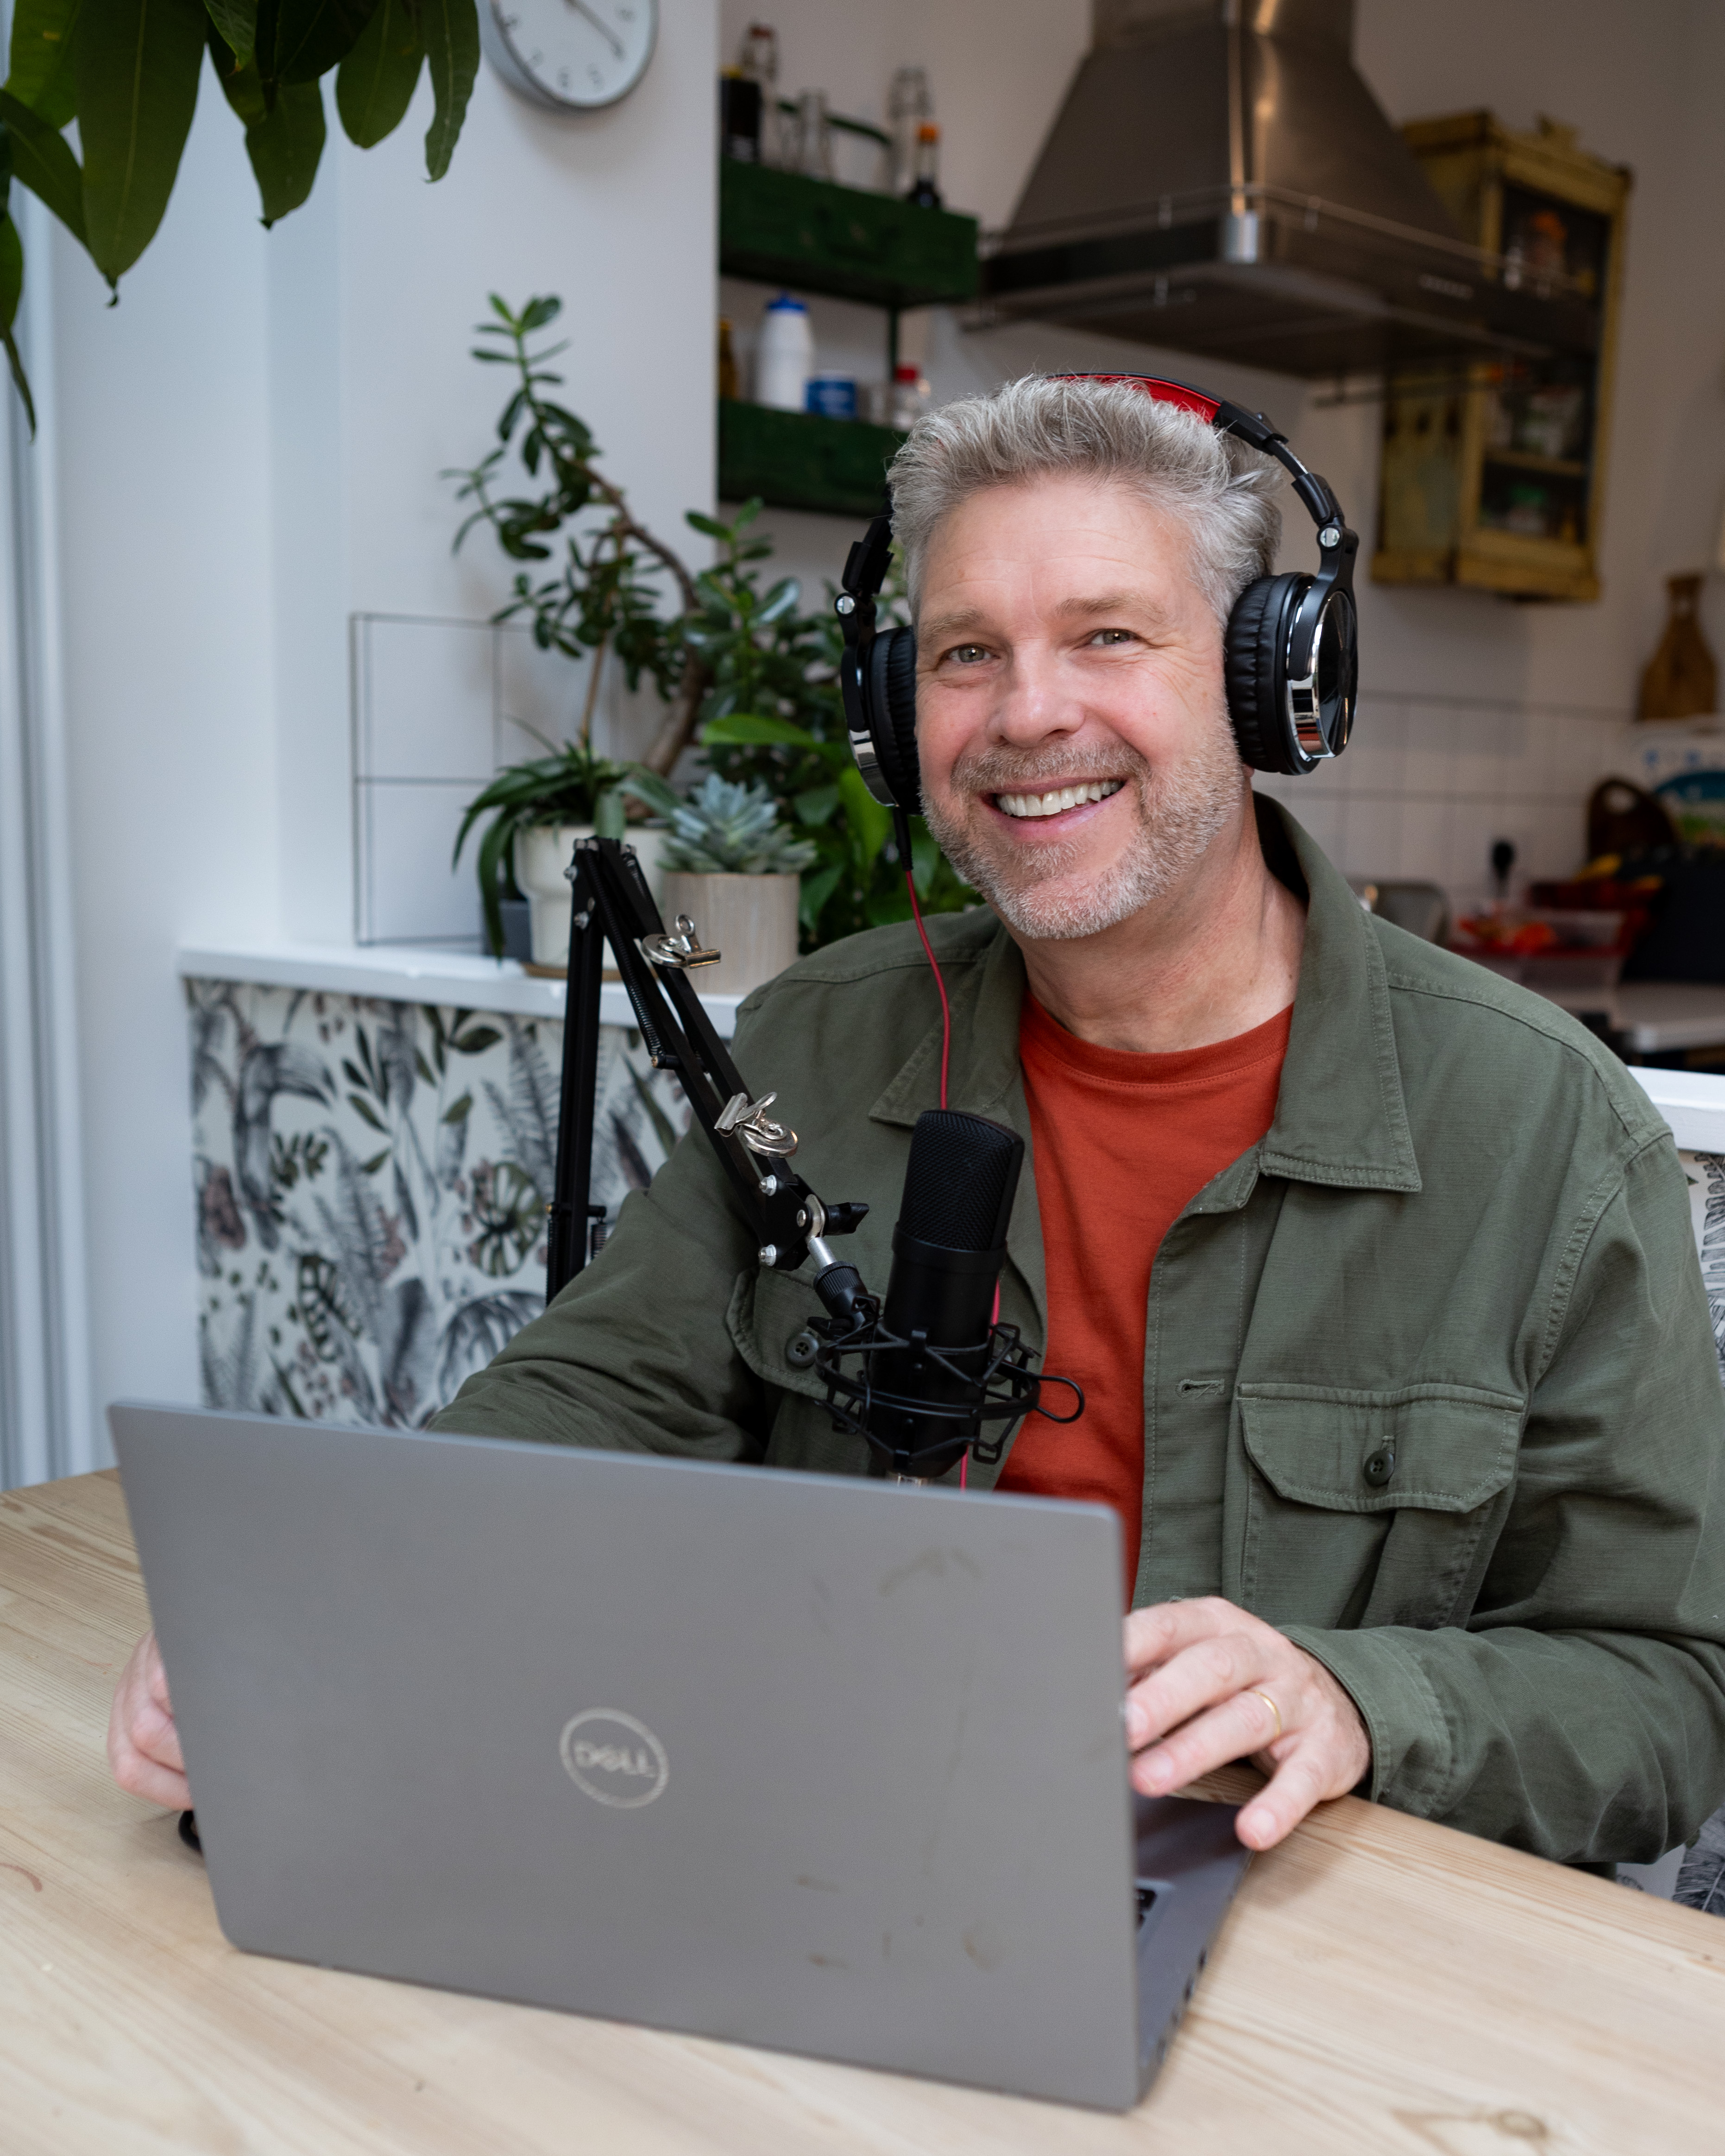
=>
[438,804,1725,1863]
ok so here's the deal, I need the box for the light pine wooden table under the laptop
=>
[0,1475,1725,2156]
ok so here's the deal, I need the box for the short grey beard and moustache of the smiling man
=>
[923,711,1248,942]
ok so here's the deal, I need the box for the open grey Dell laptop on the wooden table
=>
[110,1403,1247,2111]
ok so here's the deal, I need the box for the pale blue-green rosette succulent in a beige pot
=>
[623,770,815,996]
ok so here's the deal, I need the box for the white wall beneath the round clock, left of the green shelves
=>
[43,0,718,1458]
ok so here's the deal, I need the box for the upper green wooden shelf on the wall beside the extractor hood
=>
[718,157,977,313]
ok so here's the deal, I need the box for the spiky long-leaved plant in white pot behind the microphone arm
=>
[455,735,628,972]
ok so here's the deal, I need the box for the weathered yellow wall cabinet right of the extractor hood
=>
[1372,112,1632,599]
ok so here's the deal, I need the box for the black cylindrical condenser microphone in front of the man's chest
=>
[867,1108,1024,1481]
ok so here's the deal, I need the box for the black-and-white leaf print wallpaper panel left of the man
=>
[185,981,688,1427]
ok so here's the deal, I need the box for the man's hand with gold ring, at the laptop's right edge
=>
[1126,1596,1372,1850]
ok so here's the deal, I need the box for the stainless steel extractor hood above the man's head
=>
[983,0,1596,375]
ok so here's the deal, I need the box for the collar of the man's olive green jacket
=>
[869,796,1421,1199]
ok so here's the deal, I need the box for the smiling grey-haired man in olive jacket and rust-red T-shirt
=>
[112,379,1725,1863]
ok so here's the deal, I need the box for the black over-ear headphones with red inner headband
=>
[832,375,1360,813]
